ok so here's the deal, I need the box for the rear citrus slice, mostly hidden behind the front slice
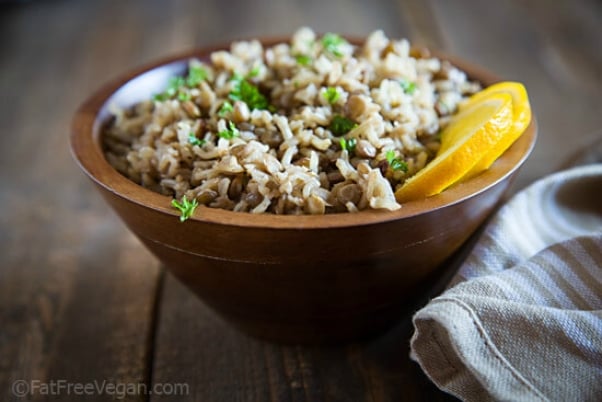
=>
[460,81,531,178]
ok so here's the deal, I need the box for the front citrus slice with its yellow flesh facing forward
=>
[395,91,514,202]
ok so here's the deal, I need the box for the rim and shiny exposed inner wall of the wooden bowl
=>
[71,40,536,229]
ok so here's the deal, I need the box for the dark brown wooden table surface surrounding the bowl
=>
[0,0,602,401]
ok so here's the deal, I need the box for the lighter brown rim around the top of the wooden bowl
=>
[70,36,537,229]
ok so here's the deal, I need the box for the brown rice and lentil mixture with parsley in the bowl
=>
[103,28,480,214]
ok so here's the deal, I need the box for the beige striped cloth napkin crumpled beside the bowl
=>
[411,164,602,401]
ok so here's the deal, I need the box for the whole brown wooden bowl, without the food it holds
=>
[71,40,536,343]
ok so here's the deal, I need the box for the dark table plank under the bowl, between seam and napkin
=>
[151,275,453,402]
